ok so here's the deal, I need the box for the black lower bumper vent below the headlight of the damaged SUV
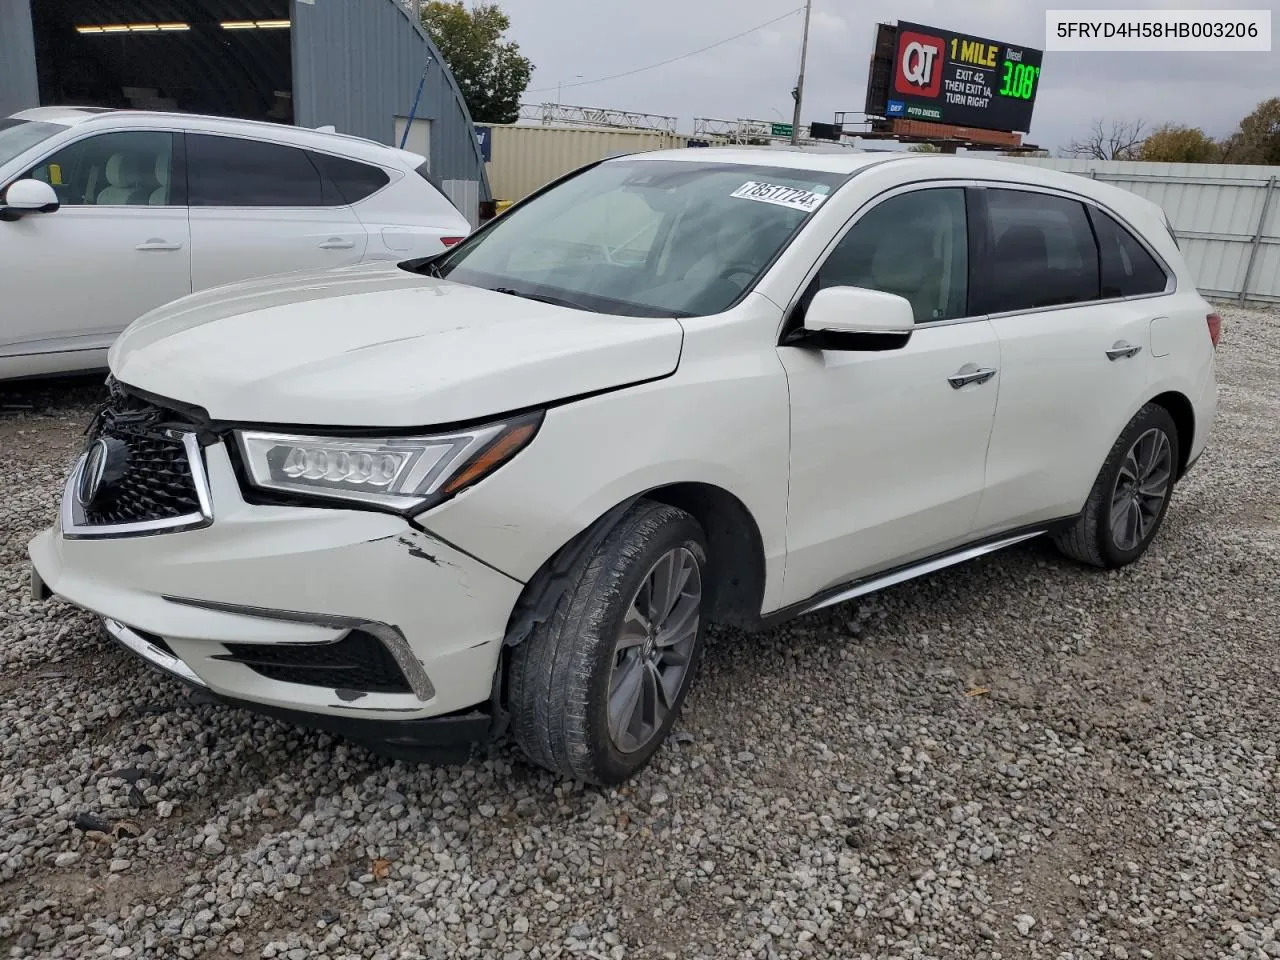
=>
[216,630,413,694]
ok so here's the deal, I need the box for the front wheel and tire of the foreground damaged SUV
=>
[508,500,707,786]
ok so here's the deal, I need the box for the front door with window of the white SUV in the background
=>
[0,131,191,357]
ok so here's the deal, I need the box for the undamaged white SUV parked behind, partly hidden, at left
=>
[0,108,471,380]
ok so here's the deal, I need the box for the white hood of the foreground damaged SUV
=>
[109,264,684,428]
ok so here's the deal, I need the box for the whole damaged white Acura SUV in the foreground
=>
[31,148,1220,783]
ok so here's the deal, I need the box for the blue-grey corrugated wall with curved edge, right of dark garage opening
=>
[292,0,492,204]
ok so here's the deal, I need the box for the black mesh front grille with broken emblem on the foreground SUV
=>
[82,394,201,526]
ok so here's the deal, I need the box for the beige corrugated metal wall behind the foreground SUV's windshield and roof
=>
[488,124,689,201]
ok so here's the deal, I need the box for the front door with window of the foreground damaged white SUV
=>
[778,187,1000,604]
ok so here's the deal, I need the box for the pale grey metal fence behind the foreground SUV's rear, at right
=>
[1004,157,1280,302]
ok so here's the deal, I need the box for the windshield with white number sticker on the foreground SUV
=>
[428,159,847,316]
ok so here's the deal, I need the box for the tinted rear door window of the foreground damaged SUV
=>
[982,189,1101,314]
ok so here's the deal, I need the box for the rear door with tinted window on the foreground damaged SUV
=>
[970,187,1166,535]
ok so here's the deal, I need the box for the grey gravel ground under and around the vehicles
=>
[0,302,1280,960]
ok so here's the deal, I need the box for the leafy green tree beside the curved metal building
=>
[422,0,534,123]
